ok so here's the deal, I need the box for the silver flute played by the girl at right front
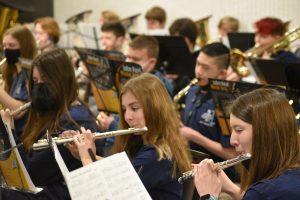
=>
[178,153,251,184]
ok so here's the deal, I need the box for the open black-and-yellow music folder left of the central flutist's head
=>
[76,48,143,113]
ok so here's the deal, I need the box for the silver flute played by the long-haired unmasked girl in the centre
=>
[32,127,148,150]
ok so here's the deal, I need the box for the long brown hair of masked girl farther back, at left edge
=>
[2,26,37,92]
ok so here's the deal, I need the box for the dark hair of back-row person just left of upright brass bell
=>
[169,18,198,44]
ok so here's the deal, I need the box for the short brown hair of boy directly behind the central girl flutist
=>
[129,35,159,58]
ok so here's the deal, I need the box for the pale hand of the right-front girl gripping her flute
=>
[194,159,222,197]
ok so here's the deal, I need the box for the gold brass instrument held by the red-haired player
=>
[230,27,300,77]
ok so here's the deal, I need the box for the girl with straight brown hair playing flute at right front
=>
[195,89,300,200]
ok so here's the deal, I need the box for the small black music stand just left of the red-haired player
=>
[228,32,255,52]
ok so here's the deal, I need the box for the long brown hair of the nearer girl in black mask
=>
[22,49,78,150]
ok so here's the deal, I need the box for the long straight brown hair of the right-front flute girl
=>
[231,89,300,190]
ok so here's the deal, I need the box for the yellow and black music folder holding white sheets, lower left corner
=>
[0,117,42,193]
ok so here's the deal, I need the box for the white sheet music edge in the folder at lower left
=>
[3,122,42,193]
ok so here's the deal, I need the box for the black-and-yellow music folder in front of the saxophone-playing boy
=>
[209,79,285,136]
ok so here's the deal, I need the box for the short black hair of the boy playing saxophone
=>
[200,42,230,69]
